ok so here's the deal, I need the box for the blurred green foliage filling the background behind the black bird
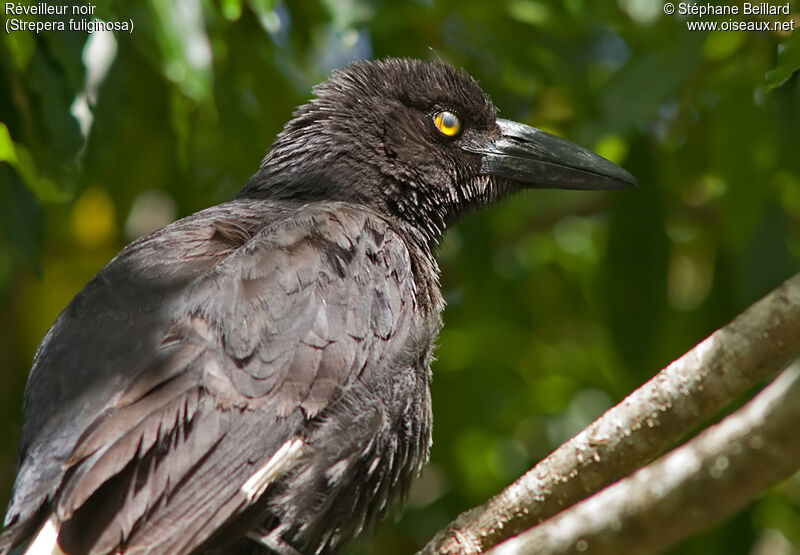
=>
[0,0,800,553]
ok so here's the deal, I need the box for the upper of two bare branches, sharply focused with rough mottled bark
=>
[422,274,800,554]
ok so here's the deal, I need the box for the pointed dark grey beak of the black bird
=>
[474,119,638,189]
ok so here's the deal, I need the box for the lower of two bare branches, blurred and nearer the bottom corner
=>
[490,364,800,555]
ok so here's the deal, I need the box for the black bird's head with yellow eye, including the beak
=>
[240,59,636,240]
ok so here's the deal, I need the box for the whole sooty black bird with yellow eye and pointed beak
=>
[0,58,637,555]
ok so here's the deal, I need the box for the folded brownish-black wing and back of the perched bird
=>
[6,201,416,553]
